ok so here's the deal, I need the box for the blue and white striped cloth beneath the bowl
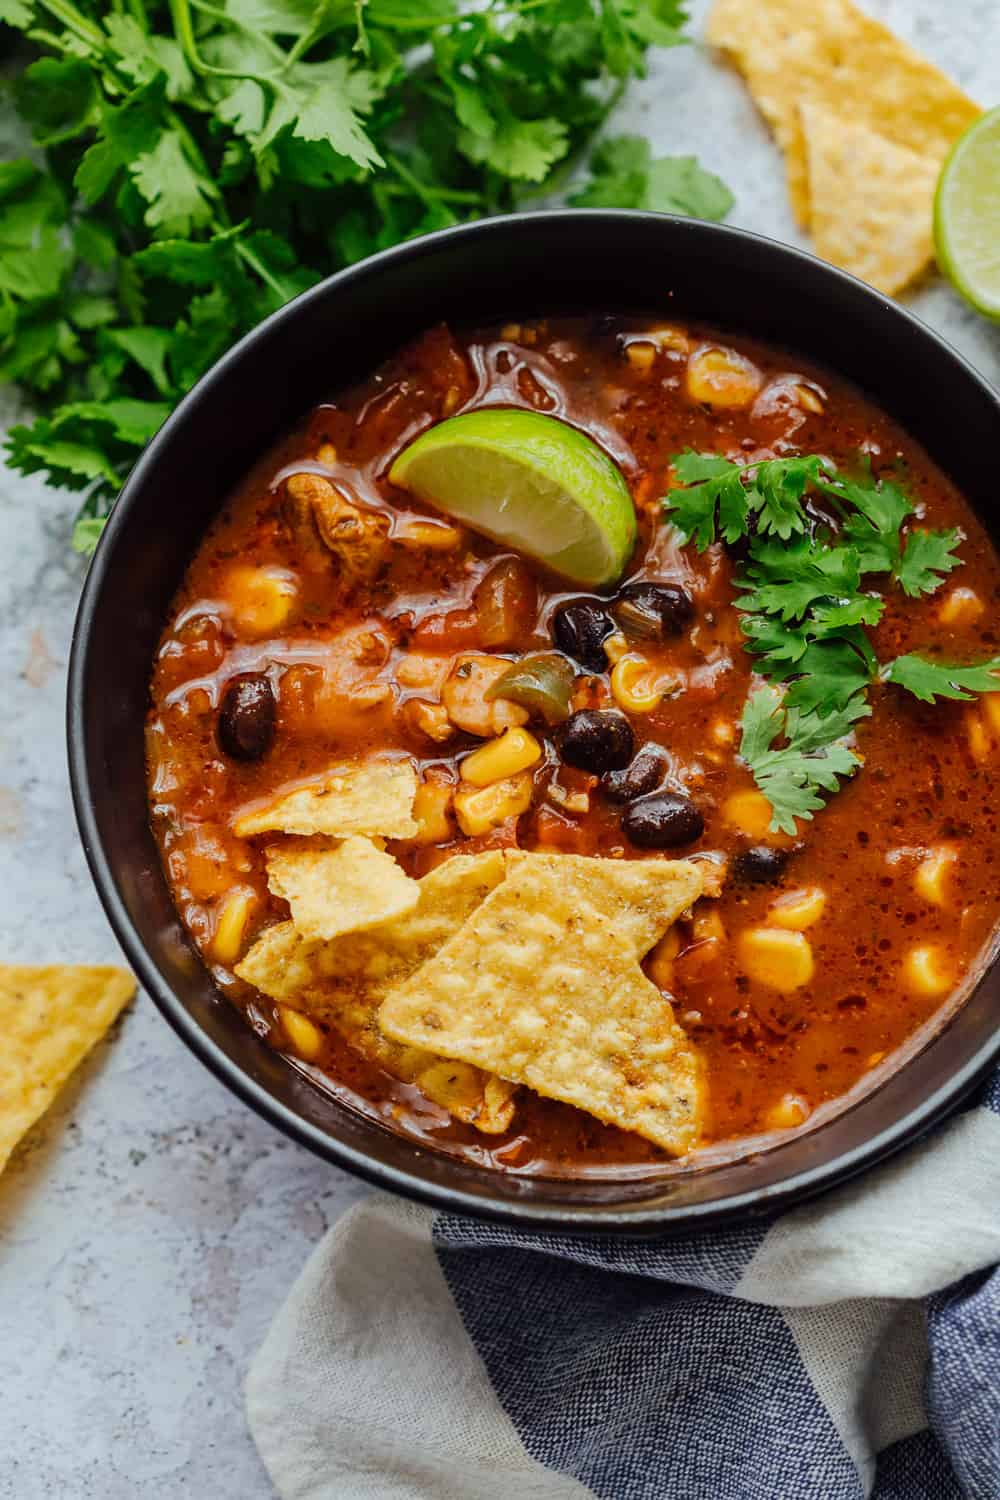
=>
[247,1074,1000,1500]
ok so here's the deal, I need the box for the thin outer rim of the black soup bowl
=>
[66,209,1000,1236]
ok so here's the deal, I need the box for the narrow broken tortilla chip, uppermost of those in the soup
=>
[232,761,417,839]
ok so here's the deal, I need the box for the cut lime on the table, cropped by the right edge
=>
[934,108,1000,318]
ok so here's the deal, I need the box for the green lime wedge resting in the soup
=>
[388,408,636,588]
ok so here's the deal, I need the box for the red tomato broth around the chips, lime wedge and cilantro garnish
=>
[147,318,1000,1173]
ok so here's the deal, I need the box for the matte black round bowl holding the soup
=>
[69,212,1000,1233]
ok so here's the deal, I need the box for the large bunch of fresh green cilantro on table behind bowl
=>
[0,0,730,551]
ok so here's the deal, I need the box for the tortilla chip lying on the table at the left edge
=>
[0,965,135,1172]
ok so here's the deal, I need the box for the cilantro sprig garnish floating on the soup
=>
[664,452,1000,833]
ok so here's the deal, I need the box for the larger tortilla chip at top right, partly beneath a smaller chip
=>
[706,0,981,228]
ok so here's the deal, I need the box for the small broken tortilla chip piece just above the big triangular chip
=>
[267,834,420,941]
